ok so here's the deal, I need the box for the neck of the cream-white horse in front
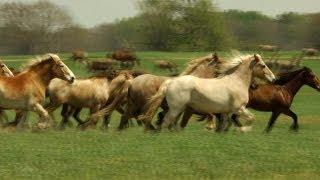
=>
[230,61,252,89]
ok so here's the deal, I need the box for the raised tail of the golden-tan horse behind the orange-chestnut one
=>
[92,74,132,117]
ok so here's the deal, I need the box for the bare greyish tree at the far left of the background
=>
[0,1,72,54]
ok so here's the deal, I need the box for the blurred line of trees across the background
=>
[0,0,320,54]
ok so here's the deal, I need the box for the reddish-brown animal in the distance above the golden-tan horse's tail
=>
[107,50,140,66]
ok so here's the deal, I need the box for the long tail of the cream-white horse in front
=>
[138,79,172,122]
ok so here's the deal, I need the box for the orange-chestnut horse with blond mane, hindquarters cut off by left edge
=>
[0,54,75,129]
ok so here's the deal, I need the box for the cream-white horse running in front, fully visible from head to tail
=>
[139,54,275,130]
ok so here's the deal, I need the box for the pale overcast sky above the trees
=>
[0,0,320,27]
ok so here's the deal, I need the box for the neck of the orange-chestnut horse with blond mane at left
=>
[27,64,55,88]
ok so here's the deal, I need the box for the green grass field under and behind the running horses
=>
[0,52,320,179]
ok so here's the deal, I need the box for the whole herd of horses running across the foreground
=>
[0,54,320,132]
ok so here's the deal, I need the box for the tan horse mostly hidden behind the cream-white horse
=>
[109,54,221,129]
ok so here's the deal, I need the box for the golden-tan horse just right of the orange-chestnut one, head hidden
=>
[47,72,132,129]
